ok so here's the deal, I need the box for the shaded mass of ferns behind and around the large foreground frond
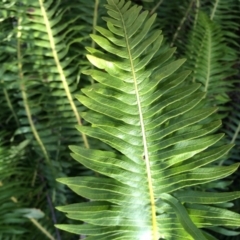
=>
[0,0,240,240]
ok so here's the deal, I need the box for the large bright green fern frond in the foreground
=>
[57,0,240,240]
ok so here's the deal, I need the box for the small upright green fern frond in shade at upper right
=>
[186,12,236,117]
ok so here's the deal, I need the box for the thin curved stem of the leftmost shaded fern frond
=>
[17,18,50,164]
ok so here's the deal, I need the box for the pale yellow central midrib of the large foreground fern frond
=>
[116,6,159,240]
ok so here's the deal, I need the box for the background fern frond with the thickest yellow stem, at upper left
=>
[16,1,88,152]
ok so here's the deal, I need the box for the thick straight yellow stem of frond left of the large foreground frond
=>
[39,0,89,148]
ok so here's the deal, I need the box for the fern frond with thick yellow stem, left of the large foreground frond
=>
[12,0,91,156]
